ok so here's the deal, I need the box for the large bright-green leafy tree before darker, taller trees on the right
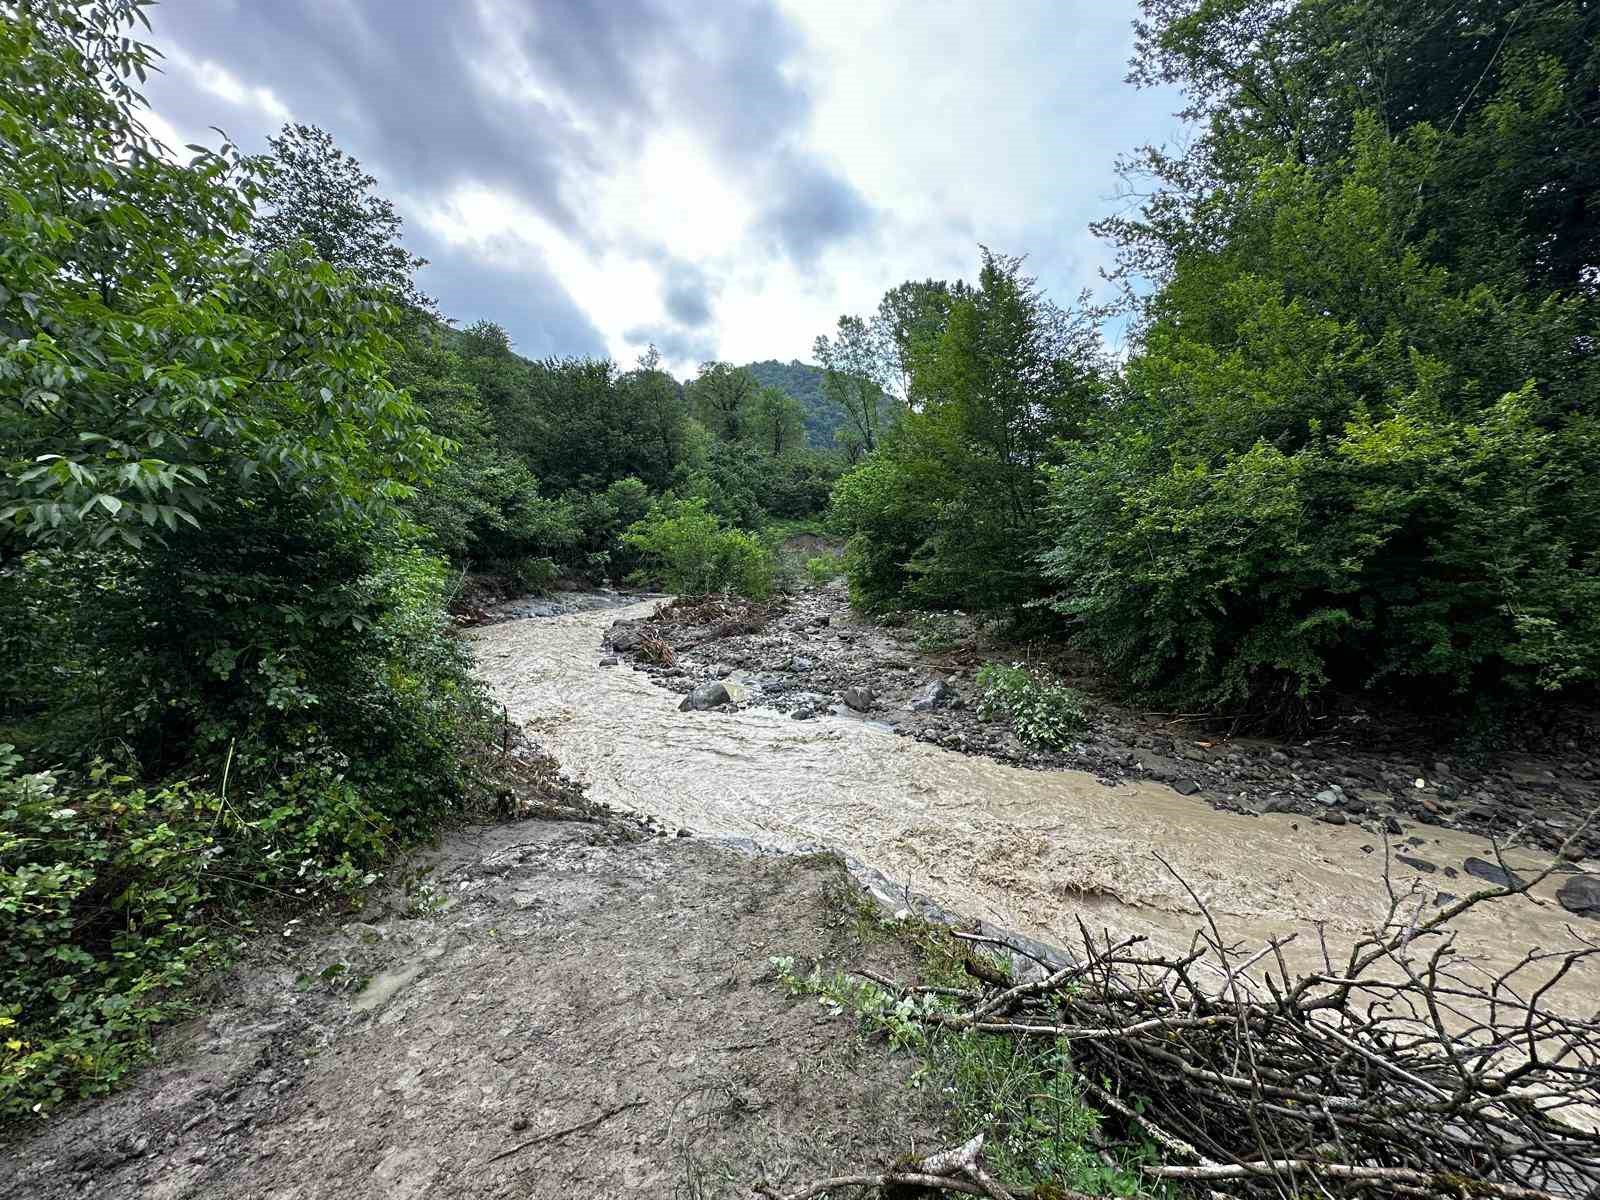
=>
[1043,112,1600,715]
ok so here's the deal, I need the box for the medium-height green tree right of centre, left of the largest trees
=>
[834,251,1102,610]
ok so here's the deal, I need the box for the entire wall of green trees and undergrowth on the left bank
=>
[0,0,492,1117]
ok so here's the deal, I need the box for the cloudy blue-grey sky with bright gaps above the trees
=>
[146,0,1179,376]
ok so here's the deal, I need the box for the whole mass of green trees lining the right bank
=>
[834,0,1600,720]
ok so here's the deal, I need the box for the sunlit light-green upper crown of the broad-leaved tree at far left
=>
[0,0,438,547]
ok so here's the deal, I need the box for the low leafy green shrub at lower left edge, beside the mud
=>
[0,746,221,1122]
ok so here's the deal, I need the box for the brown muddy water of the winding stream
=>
[474,605,1600,998]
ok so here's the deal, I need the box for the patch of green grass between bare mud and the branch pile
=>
[773,888,1155,1197]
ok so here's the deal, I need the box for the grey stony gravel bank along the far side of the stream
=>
[606,584,1600,858]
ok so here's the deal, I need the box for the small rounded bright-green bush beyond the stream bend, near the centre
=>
[622,498,774,600]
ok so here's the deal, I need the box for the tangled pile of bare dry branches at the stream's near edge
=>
[766,838,1600,1200]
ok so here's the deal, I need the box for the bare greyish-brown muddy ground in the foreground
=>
[0,818,941,1200]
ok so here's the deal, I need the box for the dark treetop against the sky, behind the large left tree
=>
[251,123,437,314]
